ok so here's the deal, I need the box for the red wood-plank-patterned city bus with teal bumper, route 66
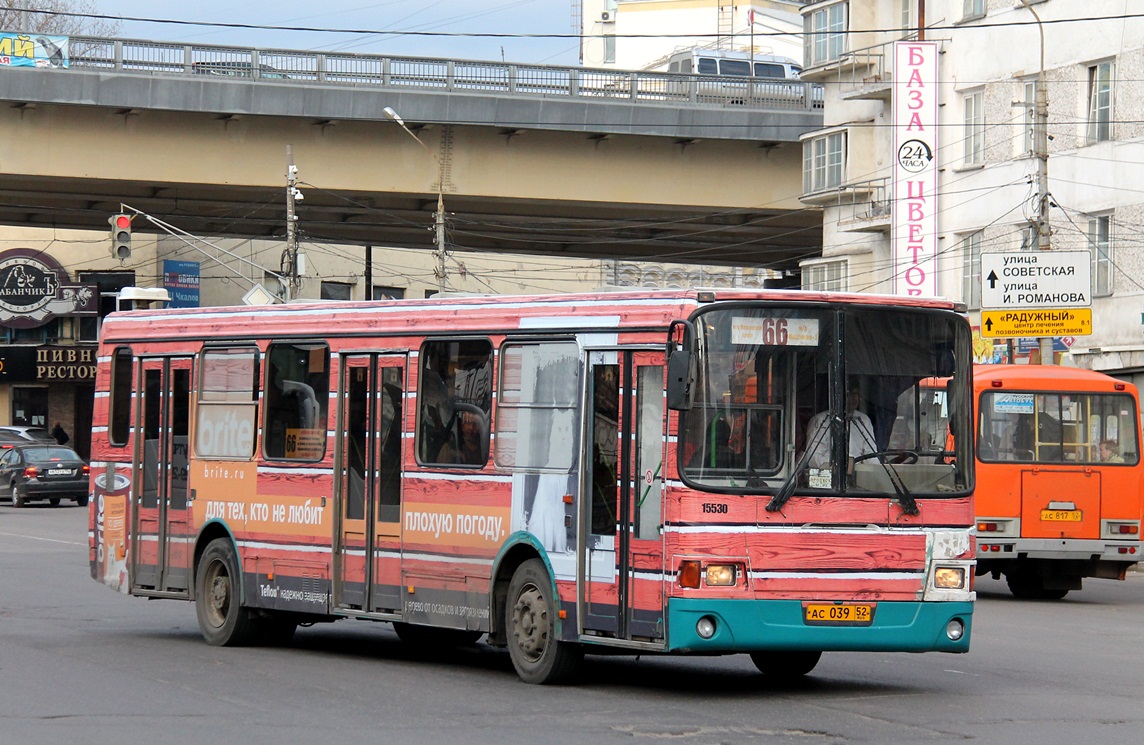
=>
[90,291,975,683]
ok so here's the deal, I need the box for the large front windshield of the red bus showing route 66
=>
[678,304,971,497]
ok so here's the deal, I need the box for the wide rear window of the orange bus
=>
[978,390,1139,465]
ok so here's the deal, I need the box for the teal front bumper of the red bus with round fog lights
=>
[667,597,974,653]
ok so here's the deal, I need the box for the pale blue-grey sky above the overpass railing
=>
[110,0,579,65]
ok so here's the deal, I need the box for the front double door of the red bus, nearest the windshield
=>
[579,351,666,642]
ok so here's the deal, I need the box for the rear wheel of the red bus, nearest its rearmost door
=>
[194,538,256,647]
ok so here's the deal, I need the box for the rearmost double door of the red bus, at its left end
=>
[132,357,193,597]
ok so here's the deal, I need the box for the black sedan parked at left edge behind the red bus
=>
[0,443,89,507]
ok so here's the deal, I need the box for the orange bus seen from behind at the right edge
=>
[974,365,1144,600]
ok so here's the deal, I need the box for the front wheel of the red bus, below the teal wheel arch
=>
[505,558,583,685]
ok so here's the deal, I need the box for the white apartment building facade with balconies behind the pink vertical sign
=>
[802,0,1144,383]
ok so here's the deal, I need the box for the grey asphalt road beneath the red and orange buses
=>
[0,502,1144,745]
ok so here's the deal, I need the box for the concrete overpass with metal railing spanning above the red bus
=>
[0,38,821,269]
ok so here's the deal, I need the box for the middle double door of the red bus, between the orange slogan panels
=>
[334,354,406,613]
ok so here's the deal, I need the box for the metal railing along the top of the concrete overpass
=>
[71,37,823,111]
